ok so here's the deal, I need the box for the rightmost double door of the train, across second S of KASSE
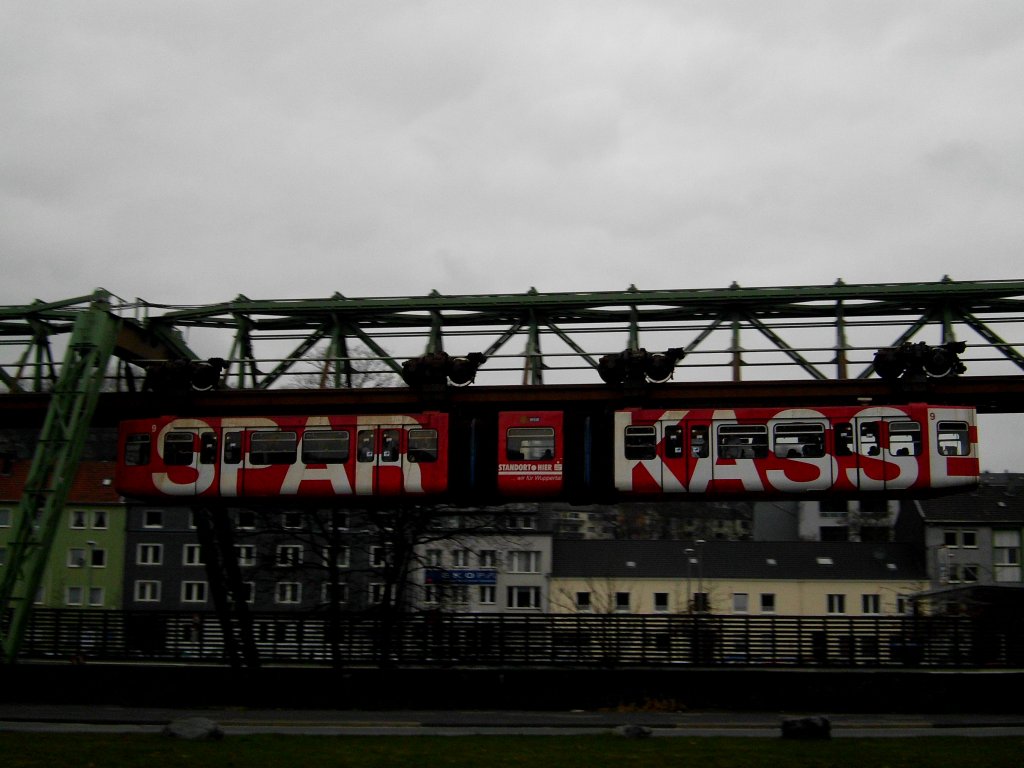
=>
[852,410,925,490]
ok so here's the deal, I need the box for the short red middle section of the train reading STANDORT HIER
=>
[498,411,564,498]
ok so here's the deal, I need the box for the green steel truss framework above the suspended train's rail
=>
[0,278,1024,392]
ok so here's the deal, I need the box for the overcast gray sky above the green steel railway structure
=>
[0,0,1024,468]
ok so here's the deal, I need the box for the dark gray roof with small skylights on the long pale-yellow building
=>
[552,540,927,581]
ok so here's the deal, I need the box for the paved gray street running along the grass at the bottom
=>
[0,705,1024,738]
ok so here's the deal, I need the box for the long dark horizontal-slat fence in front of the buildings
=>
[14,608,1024,669]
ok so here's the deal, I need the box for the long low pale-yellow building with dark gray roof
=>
[548,541,929,616]
